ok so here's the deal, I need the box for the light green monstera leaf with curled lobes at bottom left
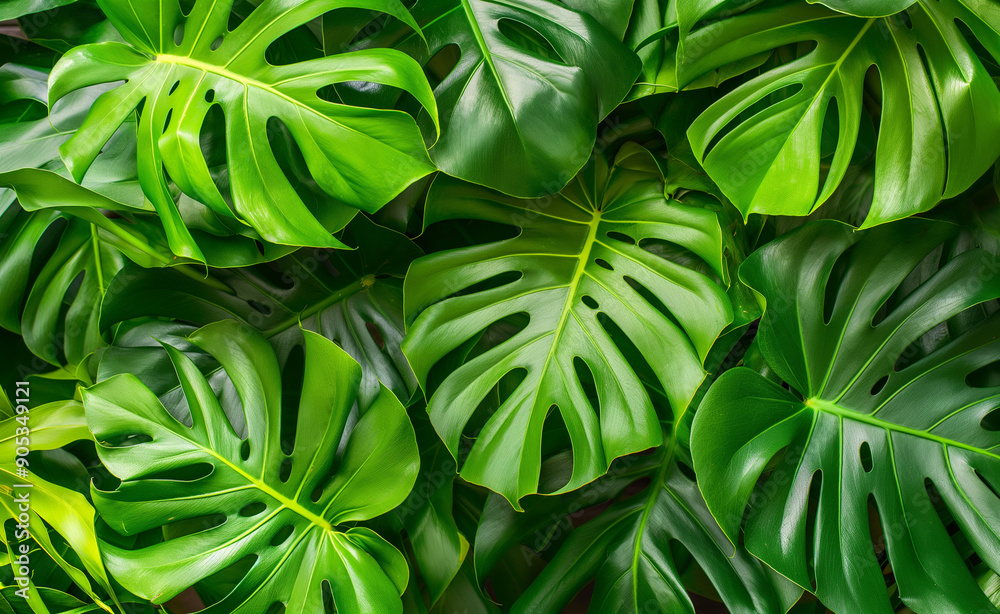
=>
[84,321,419,614]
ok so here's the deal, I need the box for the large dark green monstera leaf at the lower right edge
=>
[692,219,1000,613]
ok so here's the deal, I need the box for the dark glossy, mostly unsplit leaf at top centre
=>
[361,0,639,197]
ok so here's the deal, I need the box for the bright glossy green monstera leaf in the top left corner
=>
[49,0,437,260]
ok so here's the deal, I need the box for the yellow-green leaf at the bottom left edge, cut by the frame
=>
[0,404,112,612]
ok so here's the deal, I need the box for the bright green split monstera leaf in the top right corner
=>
[677,0,1000,227]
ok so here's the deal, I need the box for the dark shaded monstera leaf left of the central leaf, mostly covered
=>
[101,216,422,409]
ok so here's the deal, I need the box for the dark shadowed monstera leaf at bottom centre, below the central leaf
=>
[475,442,802,614]
